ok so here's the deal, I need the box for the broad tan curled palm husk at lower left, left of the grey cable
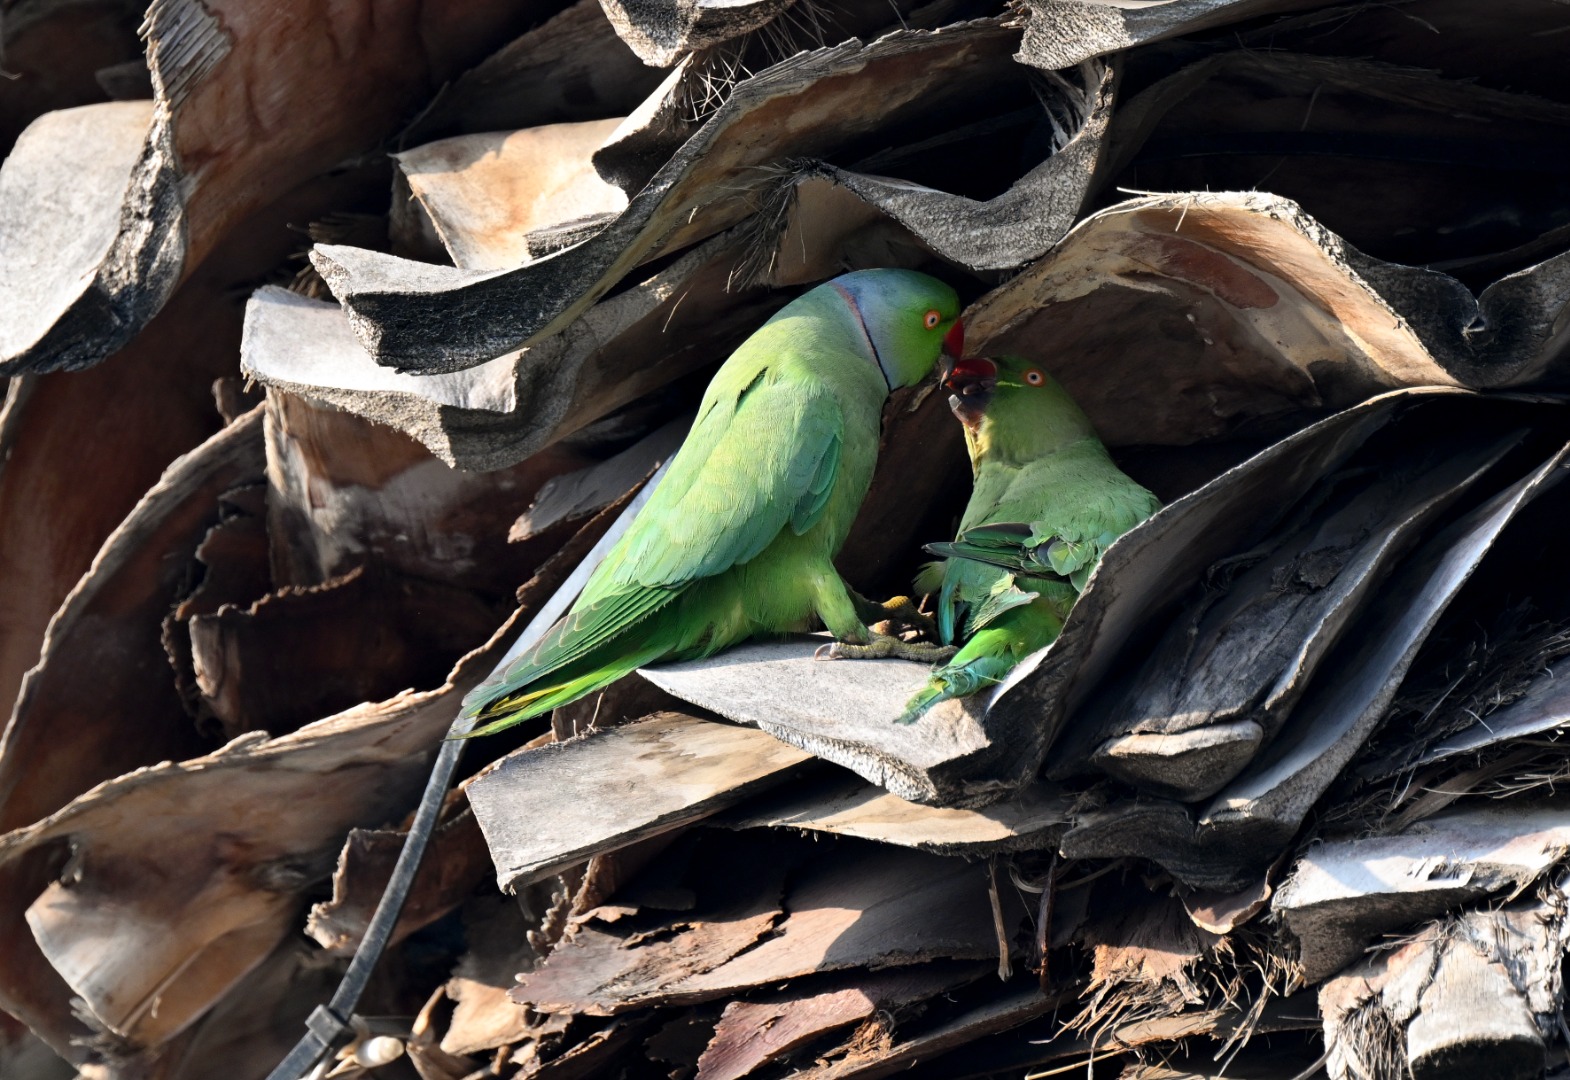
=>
[3,527,599,1045]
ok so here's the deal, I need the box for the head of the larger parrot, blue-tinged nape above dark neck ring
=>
[827,270,966,389]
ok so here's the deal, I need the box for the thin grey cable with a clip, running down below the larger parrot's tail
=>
[267,719,473,1080]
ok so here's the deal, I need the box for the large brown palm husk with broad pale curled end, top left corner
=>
[0,0,562,372]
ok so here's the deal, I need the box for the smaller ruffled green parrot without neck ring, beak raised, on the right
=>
[900,356,1160,724]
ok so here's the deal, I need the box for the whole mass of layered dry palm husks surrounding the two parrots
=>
[0,0,1570,1080]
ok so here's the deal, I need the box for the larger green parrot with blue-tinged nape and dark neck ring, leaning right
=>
[463,270,964,735]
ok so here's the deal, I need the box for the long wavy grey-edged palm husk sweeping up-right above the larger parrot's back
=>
[312,20,1067,374]
